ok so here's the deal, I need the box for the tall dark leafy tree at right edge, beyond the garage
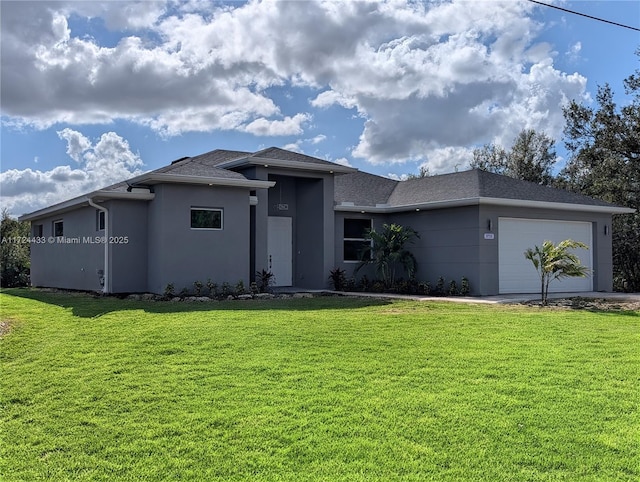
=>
[558,58,640,291]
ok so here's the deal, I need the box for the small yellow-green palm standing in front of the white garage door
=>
[524,239,589,305]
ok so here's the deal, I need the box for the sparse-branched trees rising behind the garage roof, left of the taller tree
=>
[471,129,556,185]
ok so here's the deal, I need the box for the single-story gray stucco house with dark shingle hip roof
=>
[20,147,632,295]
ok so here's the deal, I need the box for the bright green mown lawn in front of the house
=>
[0,290,640,482]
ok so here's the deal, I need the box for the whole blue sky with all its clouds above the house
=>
[0,0,640,215]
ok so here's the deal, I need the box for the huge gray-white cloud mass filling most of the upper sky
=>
[2,0,586,172]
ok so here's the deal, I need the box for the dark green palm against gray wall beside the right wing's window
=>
[356,224,420,288]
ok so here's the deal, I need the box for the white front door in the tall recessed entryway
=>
[267,216,293,286]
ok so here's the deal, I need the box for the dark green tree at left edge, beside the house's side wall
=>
[0,209,30,287]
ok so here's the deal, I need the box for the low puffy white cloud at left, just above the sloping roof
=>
[0,128,143,216]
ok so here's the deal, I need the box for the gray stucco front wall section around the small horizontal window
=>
[147,184,250,293]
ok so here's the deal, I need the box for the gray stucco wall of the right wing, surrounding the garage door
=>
[335,205,613,295]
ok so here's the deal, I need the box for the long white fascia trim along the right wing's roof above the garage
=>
[334,197,635,214]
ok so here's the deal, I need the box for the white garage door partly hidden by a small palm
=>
[498,218,593,293]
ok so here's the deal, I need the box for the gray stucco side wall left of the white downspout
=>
[31,207,104,291]
